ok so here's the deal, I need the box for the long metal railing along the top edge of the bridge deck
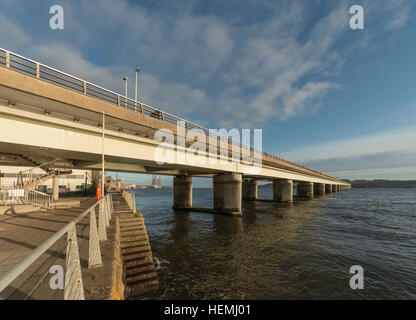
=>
[0,48,344,184]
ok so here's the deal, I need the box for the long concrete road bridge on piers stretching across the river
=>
[0,49,350,214]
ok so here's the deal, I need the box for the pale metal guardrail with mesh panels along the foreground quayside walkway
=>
[0,195,113,300]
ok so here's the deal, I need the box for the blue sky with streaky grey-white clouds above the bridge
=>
[0,0,416,184]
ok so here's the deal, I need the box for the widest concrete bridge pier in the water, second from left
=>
[213,174,242,215]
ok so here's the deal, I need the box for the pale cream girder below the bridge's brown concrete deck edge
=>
[0,101,340,184]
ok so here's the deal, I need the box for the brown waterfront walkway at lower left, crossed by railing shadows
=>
[0,198,115,300]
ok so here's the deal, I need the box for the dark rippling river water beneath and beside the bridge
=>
[131,188,416,299]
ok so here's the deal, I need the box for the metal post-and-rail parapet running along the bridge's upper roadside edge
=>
[0,48,334,180]
